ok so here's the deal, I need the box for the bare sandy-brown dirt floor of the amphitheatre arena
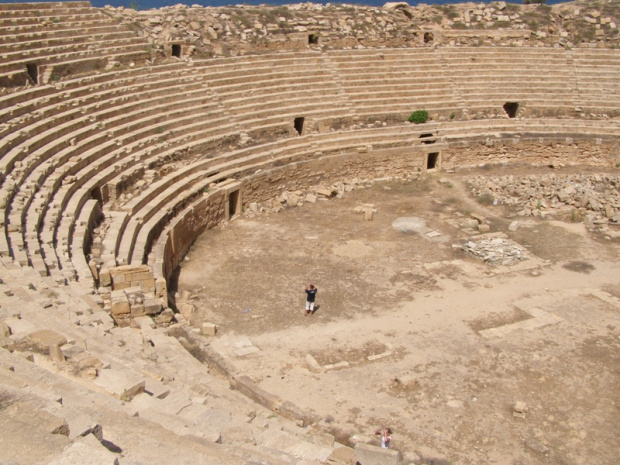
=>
[178,167,620,465]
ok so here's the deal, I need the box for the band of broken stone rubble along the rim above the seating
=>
[104,0,620,58]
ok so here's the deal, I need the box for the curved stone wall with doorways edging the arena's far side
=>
[154,135,620,298]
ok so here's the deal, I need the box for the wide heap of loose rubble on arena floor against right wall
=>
[469,174,620,224]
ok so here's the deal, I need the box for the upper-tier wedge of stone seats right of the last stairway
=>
[572,49,620,116]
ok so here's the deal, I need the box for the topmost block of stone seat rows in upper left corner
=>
[0,0,150,87]
